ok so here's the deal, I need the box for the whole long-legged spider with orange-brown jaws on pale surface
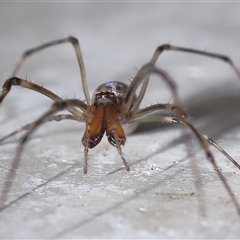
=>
[0,36,240,212]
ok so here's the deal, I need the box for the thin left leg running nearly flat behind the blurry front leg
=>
[0,114,80,144]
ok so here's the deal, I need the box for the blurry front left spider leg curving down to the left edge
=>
[0,99,89,209]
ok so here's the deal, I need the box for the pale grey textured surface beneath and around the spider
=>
[0,2,240,238]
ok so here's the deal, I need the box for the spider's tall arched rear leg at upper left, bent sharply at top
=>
[11,36,91,105]
